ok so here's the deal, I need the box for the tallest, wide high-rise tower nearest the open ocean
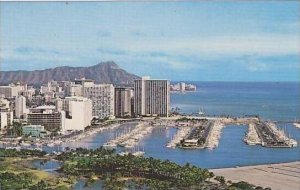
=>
[134,77,170,117]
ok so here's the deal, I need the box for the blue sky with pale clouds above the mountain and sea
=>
[0,1,300,81]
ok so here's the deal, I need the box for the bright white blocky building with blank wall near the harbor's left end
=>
[56,96,93,132]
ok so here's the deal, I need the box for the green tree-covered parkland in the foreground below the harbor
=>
[0,147,270,190]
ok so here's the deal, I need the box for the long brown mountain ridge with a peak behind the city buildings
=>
[0,61,140,85]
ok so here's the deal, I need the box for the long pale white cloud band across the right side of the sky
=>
[119,35,300,56]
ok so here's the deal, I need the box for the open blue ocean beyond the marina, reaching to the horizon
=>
[171,82,300,121]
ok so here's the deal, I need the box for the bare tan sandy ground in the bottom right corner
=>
[210,161,300,190]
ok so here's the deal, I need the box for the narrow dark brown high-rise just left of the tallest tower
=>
[115,87,133,117]
